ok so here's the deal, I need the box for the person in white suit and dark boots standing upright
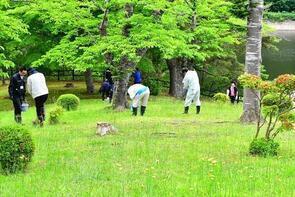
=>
[182,68,201,114]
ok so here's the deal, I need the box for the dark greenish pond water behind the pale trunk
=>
[262,31,295,79]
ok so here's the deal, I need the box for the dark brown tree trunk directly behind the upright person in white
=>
[167,58,186,98]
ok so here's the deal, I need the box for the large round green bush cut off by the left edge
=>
[0,126,35,174]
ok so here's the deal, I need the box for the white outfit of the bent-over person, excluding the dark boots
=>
[128,84,150,108]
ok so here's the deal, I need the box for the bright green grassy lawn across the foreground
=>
[0,81,295,197]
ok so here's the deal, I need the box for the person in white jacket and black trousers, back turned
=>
[27,68,48,126]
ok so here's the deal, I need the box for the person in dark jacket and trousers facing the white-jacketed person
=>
[8,67,27,123]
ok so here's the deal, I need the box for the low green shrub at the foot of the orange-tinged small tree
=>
[249,138,279,157]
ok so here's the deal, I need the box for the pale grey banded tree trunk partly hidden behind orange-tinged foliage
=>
[241,0,264,123]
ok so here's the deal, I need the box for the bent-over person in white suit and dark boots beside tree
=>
[128,84,150,116]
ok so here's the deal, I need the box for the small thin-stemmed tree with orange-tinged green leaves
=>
[239,74,295,146]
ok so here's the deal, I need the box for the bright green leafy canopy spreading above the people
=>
[3,0,243,74]
